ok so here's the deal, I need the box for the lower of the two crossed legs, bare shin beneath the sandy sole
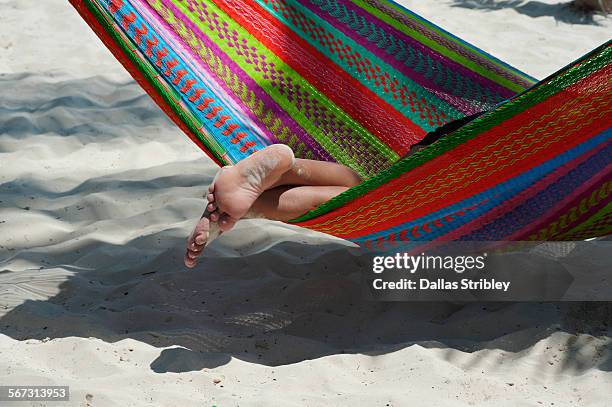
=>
[247,186,348,221]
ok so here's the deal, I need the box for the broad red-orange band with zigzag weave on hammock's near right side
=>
[298,67,612,238]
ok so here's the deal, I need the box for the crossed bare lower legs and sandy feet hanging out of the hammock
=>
[185,145,361,267]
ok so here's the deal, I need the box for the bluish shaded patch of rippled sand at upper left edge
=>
[0,73,169,142]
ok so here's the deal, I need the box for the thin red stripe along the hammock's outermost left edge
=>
[69,0,225,166]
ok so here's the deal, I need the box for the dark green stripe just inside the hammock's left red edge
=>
[84,0,229,164]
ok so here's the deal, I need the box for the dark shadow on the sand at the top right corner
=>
[453,0,600,25]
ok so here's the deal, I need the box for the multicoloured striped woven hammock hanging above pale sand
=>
[71,0,612,248]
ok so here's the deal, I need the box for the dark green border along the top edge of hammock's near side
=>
[289,41,612,223]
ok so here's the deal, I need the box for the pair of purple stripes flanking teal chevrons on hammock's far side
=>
[305,0,515,107]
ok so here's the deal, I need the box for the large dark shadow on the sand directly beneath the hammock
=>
[0,230,612,373]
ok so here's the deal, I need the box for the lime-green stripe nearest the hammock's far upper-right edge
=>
[351,0,525,92]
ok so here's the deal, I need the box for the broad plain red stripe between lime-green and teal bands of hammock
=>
[214,0,425,155]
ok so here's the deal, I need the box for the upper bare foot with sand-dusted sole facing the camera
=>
[208,144,295,232]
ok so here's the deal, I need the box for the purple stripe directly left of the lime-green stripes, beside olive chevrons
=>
[152,0,335,161]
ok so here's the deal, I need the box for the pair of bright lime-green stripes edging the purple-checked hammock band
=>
[169,1,399,176]
